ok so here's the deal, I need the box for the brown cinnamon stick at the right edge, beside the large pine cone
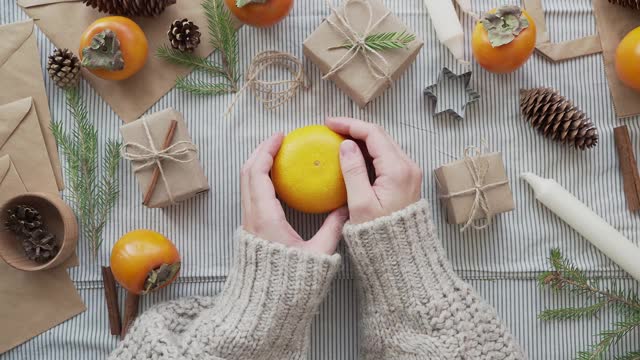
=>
[613,126,640,212]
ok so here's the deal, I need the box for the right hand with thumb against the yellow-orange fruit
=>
[326,118,422,224]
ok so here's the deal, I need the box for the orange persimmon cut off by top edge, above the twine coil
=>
[225,0,293,27]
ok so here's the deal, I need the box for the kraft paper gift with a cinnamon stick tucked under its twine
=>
[120,109,209,208]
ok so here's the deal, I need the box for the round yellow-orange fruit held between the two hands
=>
[271,125,347,214]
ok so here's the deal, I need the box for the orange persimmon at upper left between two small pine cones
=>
[80,16,149,80]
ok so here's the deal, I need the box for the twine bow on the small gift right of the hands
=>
[436,146,509,232]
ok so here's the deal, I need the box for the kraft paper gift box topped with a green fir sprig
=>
[304,0,423,107]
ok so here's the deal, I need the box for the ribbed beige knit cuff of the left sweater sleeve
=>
[188,229,340,359]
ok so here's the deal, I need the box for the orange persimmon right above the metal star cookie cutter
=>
[471,6,536,74]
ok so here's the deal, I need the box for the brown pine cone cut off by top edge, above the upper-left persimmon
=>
[82,0,176,17]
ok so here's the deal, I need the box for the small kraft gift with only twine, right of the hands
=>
[435,147,515,231]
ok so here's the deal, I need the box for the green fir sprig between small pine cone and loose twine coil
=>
[156,0,240,95]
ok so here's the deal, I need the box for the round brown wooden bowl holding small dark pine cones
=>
[0,193,78,271]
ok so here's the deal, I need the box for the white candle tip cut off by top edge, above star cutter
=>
[424,0,464,60]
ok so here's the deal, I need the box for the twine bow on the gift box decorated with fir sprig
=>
[322,0,393,85]
